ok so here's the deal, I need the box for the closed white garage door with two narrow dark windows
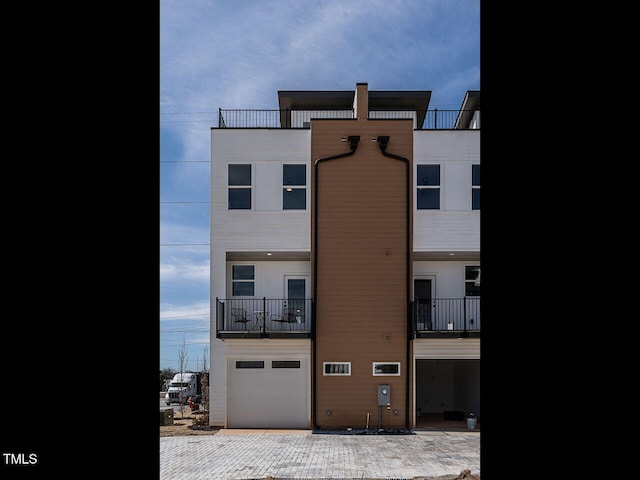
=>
[227,358,311,428]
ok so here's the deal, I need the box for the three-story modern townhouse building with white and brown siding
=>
[209,83,481,429]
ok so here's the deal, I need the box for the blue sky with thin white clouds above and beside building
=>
[159,0,480,369]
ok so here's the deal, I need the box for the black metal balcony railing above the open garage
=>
[412,297,480,332]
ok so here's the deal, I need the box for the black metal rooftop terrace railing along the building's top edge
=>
[218,108,476,130]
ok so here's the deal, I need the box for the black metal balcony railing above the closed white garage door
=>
[216,297,311,333]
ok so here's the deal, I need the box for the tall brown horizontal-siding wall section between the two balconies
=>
[311,120,413,428]
